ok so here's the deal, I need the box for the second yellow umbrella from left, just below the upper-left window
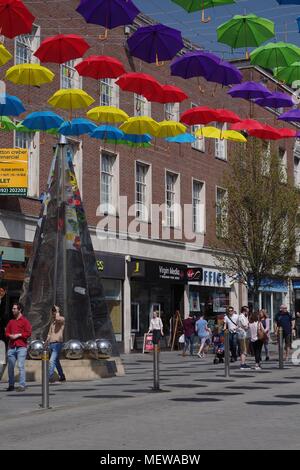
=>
[5,64,54,86]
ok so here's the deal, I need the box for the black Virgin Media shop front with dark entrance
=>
[129,259,187,350]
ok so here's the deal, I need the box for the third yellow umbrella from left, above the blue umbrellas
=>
[48,88,95,110]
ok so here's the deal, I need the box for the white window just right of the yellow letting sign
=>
[15,127,40,197]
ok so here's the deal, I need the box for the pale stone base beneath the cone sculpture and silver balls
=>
[2,357,125,383]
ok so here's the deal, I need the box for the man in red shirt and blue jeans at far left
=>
[5,303,32,392]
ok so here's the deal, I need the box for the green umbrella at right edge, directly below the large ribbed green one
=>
[250,42,300,70]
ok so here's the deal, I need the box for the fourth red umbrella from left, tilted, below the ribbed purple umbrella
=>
[116,72,161,101]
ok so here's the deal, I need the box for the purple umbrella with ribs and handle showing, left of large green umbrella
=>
[127,24,184,65]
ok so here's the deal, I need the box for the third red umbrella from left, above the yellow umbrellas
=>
[75,55,125,80]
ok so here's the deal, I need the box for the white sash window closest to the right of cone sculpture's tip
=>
[100,152,119,215]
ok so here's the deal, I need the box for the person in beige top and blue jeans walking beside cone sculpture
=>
[45,305,66,383]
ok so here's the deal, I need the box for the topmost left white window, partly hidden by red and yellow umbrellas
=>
[15,26,41,65]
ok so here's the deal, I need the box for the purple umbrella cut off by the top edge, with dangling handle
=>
[76,0,140,39]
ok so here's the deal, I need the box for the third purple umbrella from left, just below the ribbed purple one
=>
[171,51,221,78]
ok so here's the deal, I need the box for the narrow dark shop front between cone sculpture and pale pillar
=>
[95,252,125,349]
